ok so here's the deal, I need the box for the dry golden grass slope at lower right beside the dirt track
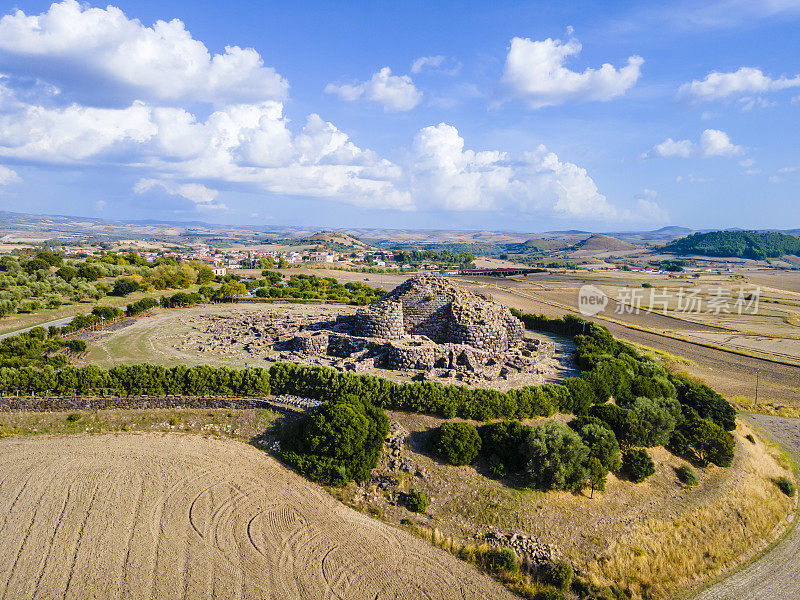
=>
[587,425,794,599]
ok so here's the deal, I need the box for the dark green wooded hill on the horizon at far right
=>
[661,231,800,260]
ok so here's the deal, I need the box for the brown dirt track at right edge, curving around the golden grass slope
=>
[695,415,800,600]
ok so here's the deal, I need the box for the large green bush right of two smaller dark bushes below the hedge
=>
[523,421,589,491]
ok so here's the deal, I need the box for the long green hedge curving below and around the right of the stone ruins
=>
[0,310,735,430]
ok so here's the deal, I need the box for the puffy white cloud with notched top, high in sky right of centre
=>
[503,37,644,108]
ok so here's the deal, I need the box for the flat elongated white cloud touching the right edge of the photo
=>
[679,67,800,102]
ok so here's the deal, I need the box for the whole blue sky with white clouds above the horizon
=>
[0,0,800,231]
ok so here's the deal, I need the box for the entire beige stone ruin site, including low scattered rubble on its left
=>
[184,274,571,385]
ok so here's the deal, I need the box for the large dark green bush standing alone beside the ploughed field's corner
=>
[281,396,389,485]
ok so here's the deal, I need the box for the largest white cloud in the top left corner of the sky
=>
[0,0,288,104]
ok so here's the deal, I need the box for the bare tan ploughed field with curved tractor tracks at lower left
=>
[0,433,511,600]
